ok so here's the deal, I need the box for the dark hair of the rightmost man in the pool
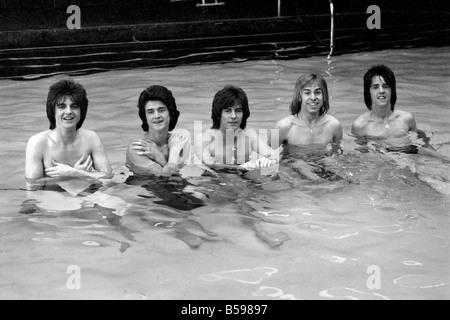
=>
[364,64,397,111]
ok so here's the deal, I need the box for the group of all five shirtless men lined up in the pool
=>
[25,65,432,190]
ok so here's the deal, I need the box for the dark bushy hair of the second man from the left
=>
[138,86,180,132]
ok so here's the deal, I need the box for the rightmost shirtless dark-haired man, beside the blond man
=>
[352,65,418,138]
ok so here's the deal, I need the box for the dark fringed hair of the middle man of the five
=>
[211,85,250,129]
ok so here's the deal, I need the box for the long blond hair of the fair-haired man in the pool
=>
[290,73,330,116]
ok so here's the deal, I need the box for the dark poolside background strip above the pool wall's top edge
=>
[0,0,448,31]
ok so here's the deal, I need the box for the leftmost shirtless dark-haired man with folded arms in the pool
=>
[25,80,112,190]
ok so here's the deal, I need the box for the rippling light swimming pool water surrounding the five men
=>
[0,47,450,300]
